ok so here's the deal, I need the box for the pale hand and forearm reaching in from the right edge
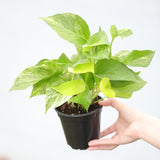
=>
[88,98,160,151]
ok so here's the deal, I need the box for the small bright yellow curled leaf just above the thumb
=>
[99,78,115,98]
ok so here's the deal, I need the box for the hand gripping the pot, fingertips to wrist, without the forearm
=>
[88,98,149,151]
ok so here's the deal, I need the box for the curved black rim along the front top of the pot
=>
[55,106,103,118]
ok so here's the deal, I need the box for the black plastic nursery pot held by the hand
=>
[56,106,102,149]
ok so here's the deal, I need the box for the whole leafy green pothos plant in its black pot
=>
[10,13,154,149]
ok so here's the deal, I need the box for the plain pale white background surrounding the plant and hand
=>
[0,0,160,160]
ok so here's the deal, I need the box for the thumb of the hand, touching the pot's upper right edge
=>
[98,98,125,110]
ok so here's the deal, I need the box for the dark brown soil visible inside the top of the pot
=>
[57,97,100,115]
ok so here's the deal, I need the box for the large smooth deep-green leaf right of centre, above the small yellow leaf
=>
[95,59,137,81]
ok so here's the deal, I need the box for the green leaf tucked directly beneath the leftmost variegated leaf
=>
[31,72,66,97]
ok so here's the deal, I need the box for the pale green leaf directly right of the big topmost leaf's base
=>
[87,31,109,46]
